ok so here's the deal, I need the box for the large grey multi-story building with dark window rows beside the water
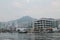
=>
[33,18,58,29]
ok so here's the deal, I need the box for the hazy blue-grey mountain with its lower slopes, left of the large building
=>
[0,16,37,28]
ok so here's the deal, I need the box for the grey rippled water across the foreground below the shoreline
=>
[0,33,60,40]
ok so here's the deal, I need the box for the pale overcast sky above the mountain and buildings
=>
[0,0,60,21]
